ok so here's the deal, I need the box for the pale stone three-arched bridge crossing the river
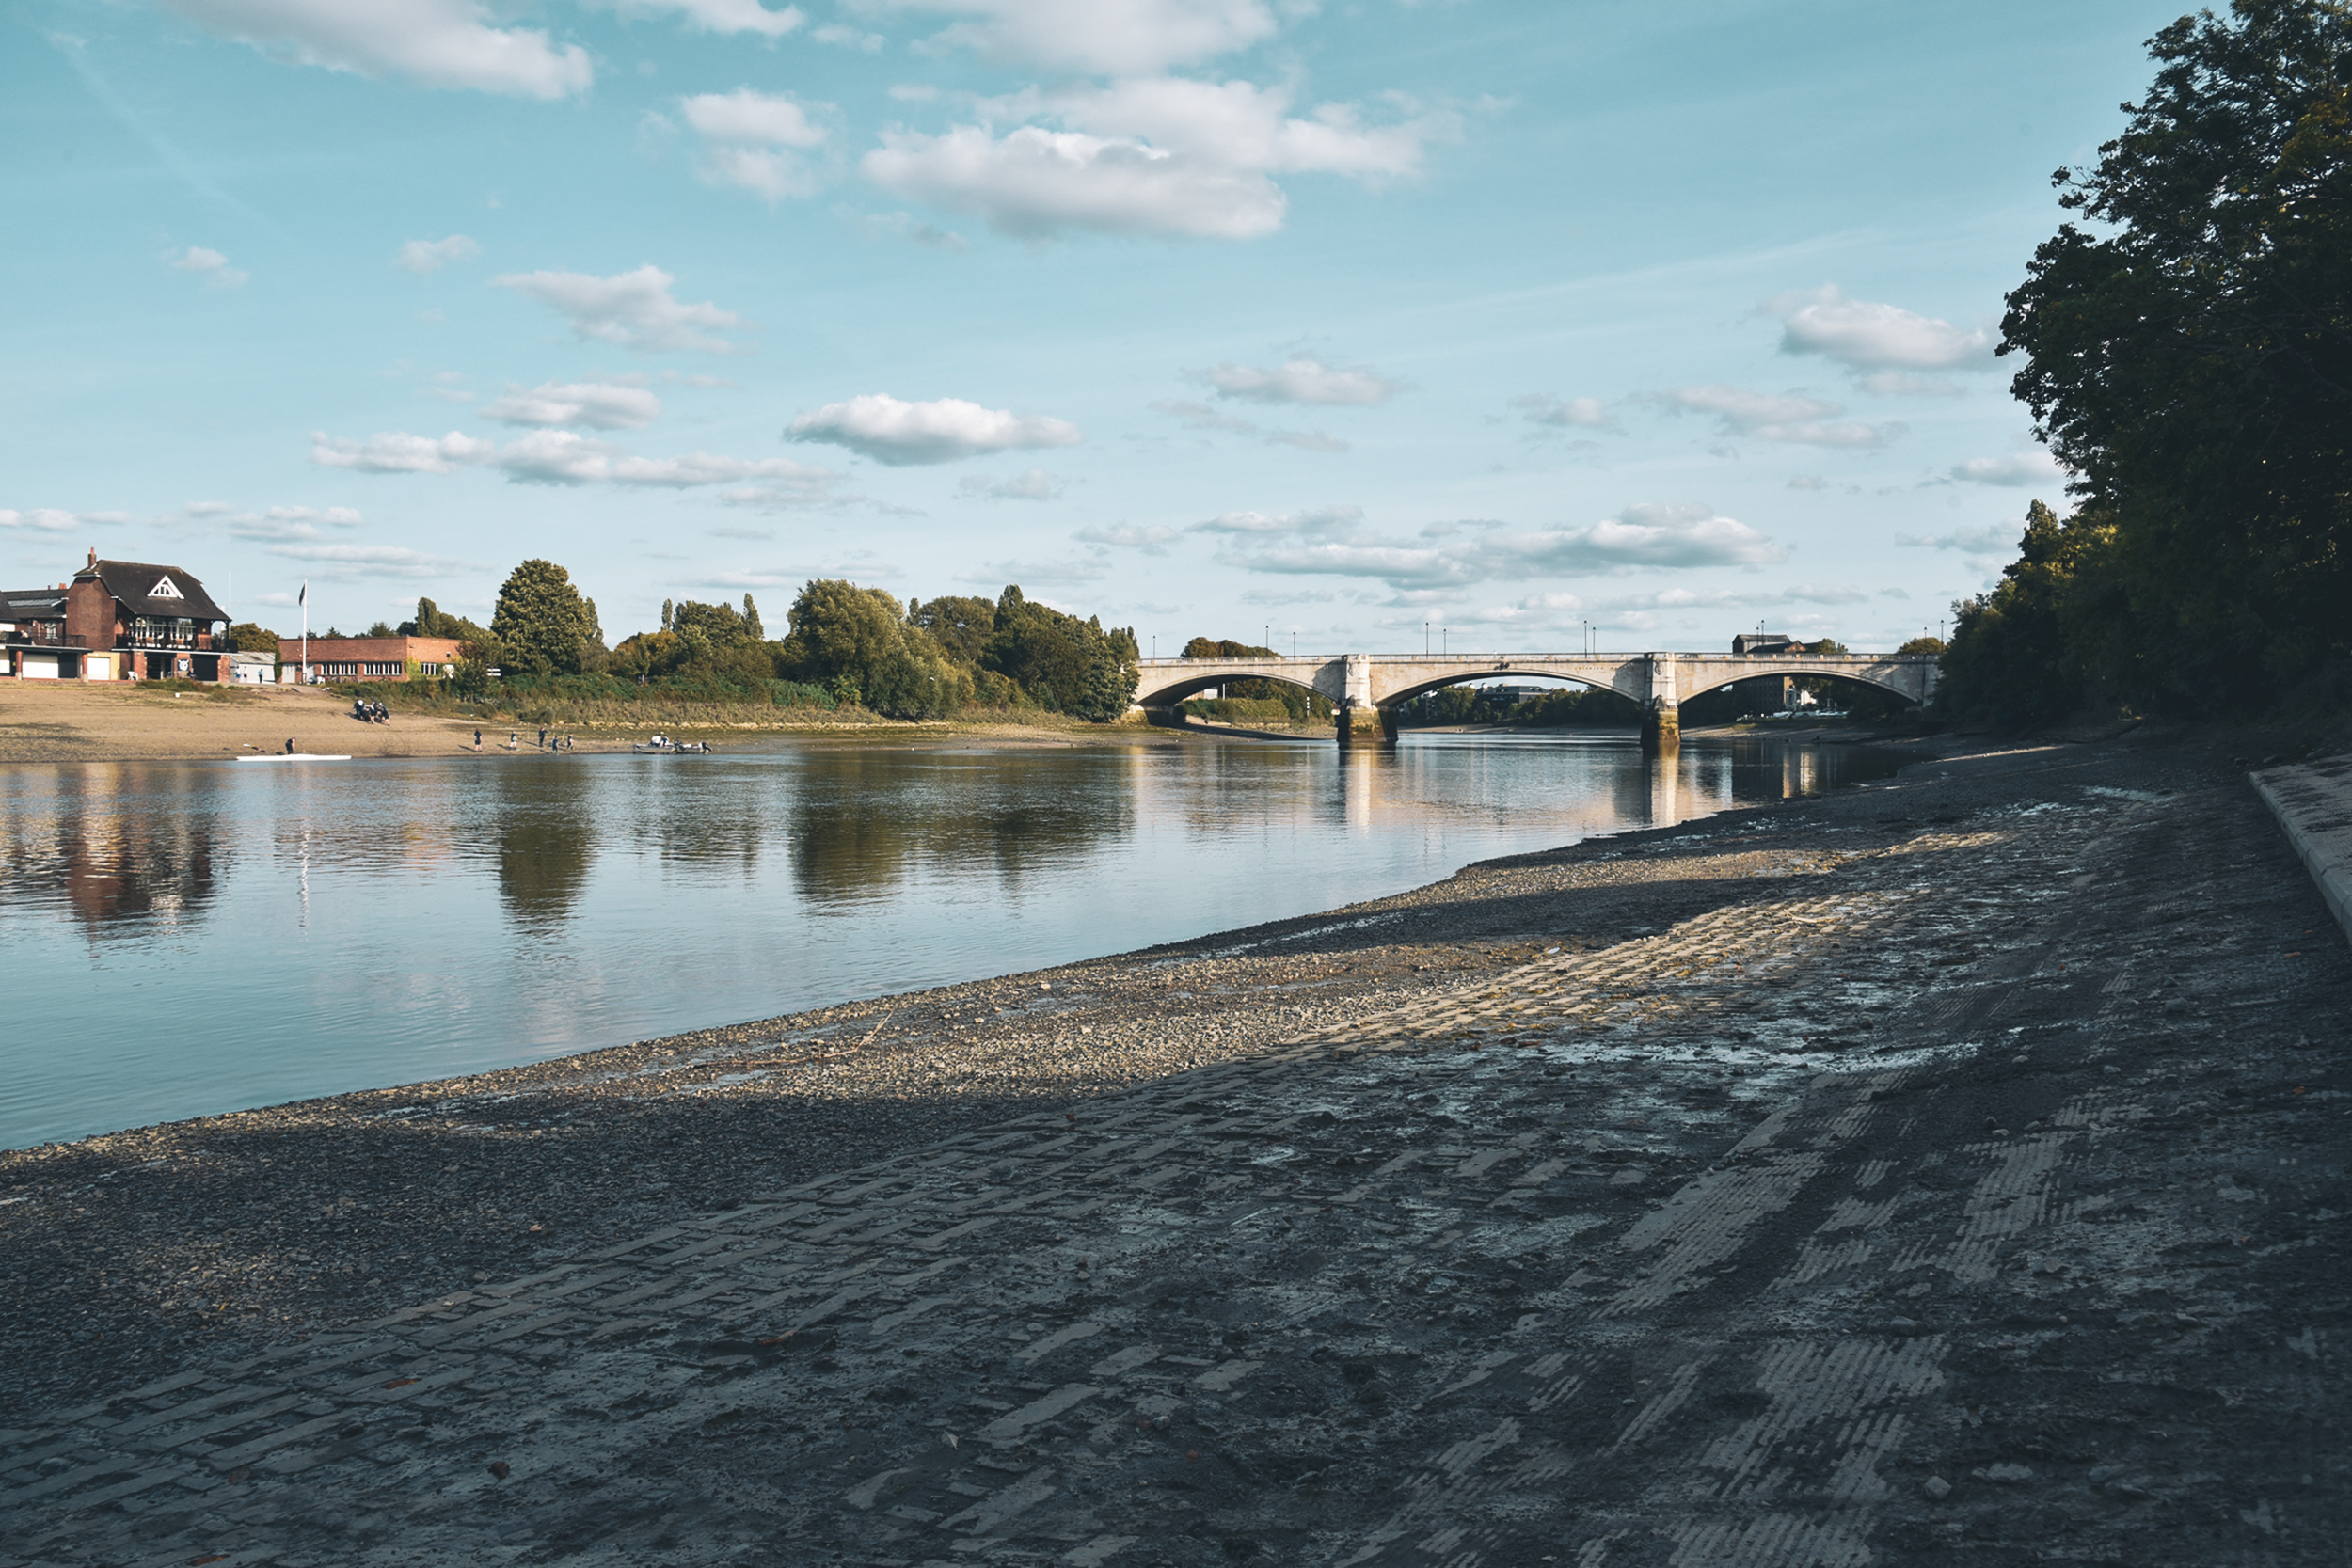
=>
[1136,654,1936,750]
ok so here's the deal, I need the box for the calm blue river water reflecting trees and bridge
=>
[0,736,1889,1148]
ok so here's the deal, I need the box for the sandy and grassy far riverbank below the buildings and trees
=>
[0,682,1176,762]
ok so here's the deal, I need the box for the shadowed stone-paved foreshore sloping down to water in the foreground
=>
[0,745,2352,1568]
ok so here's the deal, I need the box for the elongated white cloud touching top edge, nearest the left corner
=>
[163,0,596,99]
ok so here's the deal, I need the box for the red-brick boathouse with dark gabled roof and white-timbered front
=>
[0,550,229,682]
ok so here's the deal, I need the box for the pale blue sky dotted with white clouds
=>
[0,0,2181,656]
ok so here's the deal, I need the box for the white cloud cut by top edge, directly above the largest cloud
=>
[887,0,1275,75]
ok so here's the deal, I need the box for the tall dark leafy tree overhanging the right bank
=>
[2002,0,2352,698]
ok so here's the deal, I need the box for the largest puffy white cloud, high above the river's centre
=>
[861,77,1461,240]
